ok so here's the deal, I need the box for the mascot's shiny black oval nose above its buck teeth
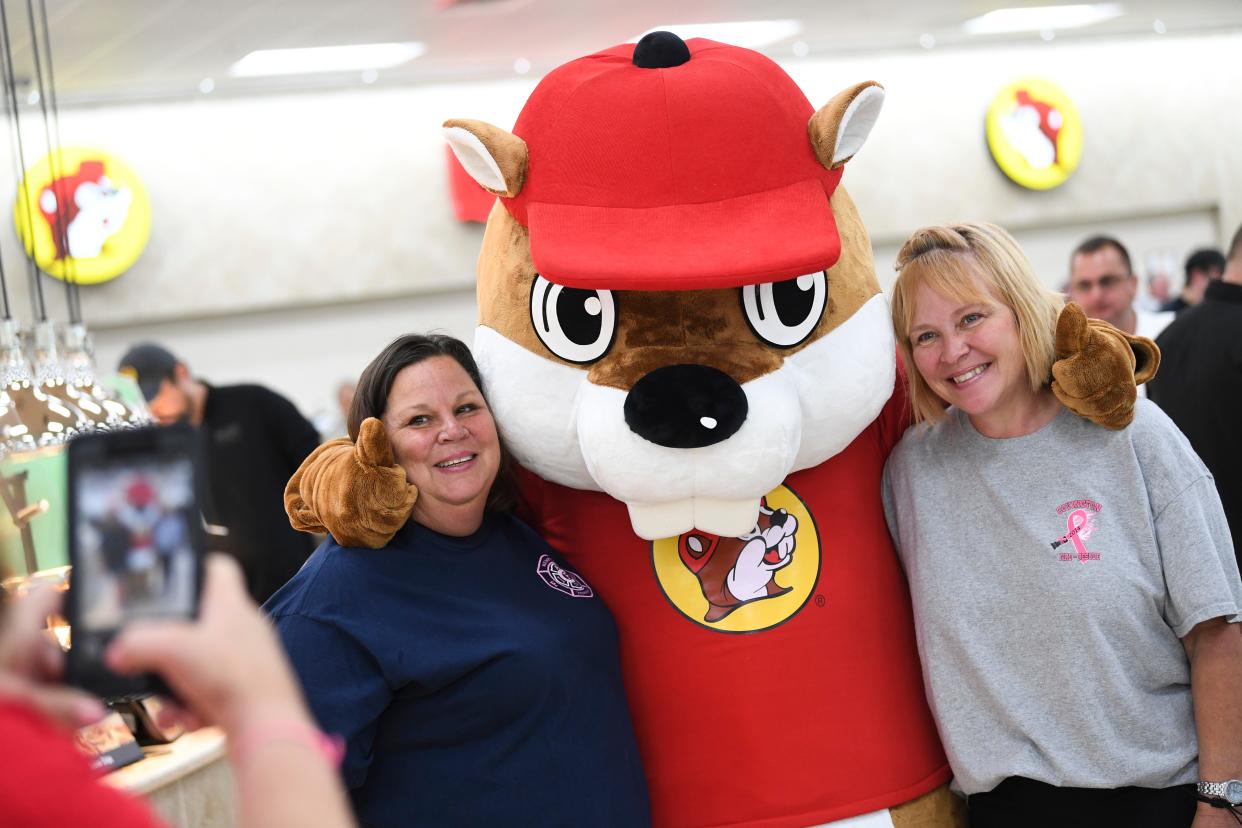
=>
[625,365,746,448]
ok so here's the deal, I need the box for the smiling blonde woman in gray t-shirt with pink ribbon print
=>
[884,223,1242,828]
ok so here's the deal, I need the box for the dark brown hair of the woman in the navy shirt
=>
[348,334,518,511]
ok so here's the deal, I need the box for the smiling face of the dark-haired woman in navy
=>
[384,356,501,534]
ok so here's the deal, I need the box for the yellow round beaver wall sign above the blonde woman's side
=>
[987,78,1083,190]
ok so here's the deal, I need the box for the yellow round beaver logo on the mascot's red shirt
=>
[651,485,820,633]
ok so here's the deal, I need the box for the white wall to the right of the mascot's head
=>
[790,35,1242,288]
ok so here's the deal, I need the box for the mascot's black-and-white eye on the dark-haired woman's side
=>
[530,276,617,362]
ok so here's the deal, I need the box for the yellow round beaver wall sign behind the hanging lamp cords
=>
[14,146,152,284]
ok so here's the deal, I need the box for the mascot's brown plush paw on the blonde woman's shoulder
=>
[1052,302,1160,430]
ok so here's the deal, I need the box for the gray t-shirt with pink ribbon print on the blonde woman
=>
[884,400,1242,793]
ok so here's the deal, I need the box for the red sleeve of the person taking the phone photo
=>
[0,703,165,828]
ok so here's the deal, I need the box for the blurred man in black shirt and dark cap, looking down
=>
[119,343,319,603]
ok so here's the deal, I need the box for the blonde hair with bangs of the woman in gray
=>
[892,222,1064,422]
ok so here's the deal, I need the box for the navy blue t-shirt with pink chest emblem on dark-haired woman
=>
[265,515,651,828]
